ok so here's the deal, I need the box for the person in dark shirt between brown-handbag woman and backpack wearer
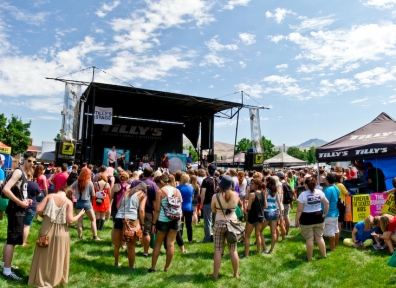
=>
[131,166,158,257]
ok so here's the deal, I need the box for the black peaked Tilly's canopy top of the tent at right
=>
[316,113,396,162]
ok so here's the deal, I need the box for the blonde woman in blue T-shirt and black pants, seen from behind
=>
[176,173,194,244]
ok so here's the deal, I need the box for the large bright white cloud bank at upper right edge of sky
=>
[288,24,396,73]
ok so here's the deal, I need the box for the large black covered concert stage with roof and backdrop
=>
[78,82,243,164]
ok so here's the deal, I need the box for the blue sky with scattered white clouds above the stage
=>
[0,0,396,146]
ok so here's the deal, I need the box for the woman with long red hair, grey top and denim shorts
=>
[70,167,101,241]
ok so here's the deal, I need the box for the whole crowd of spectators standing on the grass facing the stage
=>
[0,152,396,287]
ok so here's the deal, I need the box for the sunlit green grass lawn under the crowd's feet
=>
[0,205,396,287]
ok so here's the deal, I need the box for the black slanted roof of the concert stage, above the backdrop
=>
[83,82,246,123]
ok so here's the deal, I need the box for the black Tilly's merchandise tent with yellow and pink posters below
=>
[316,113,396,230]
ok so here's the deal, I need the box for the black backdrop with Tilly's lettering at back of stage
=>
[93,118,183,166]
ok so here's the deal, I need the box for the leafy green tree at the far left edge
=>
[0,114,32,155]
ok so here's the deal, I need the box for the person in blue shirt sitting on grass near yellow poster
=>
[344,215,374,248]
